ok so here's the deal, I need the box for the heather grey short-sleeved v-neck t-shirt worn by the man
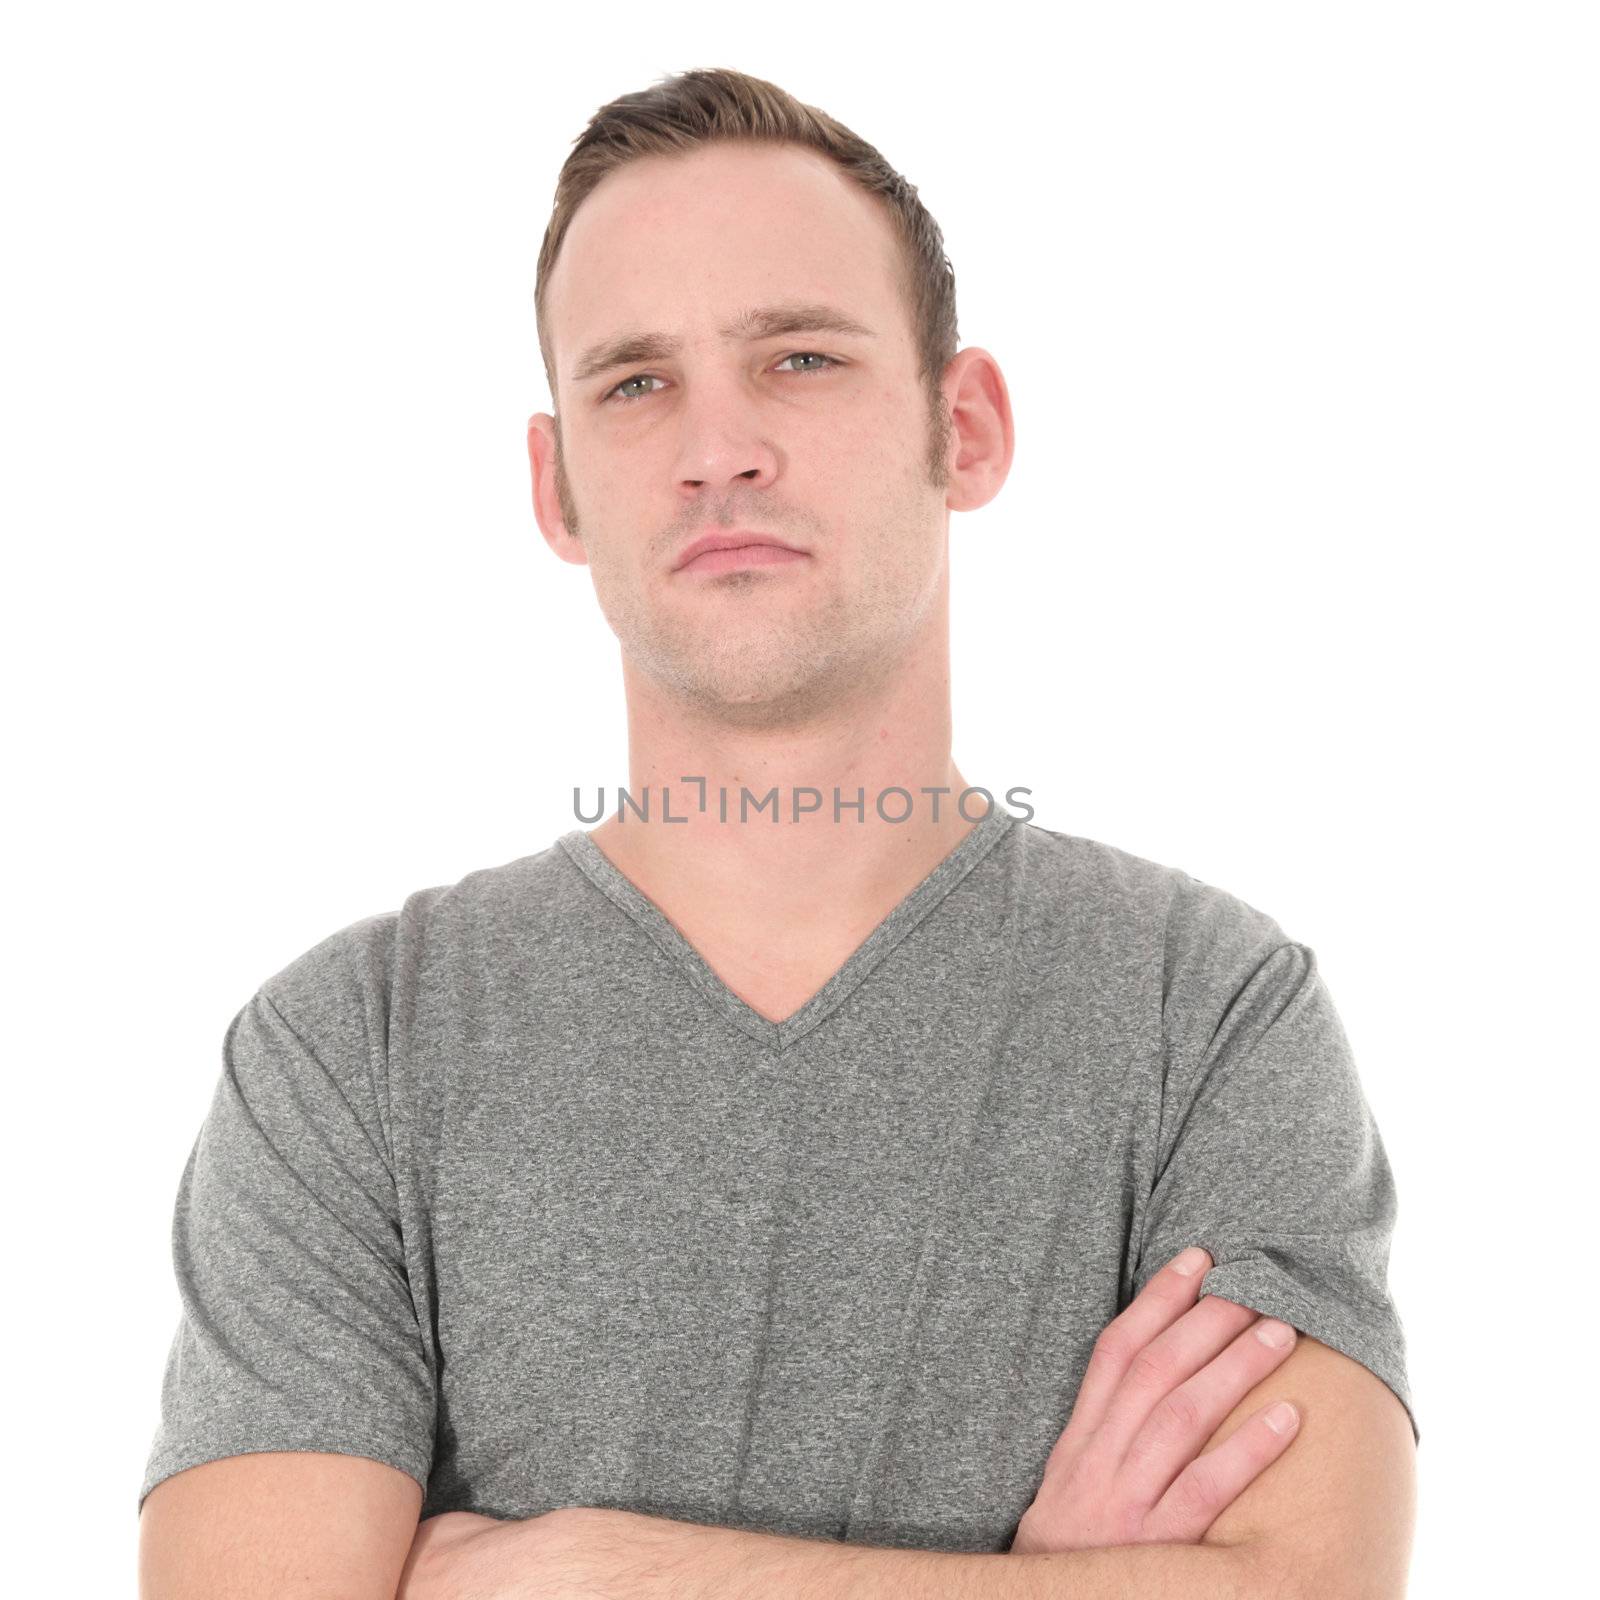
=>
[139,810,1421,1550]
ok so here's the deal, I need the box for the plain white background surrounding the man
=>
[0,0,1600,1597]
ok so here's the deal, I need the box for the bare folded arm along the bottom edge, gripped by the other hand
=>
[397,1336,1414,1600]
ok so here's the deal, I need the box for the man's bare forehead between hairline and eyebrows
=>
[546,144,909,384]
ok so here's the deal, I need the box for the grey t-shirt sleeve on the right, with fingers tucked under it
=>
[1134,891,1422,1443]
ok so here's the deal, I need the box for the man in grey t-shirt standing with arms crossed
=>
[141,72,1419,1597]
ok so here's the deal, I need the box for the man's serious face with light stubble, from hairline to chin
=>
[546,146,950,725]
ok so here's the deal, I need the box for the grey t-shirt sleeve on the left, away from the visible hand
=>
[139,934,435,1509]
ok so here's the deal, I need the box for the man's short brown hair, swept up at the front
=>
[533,67,958,422]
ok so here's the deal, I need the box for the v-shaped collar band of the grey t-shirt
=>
[557,805,1016,1053]
